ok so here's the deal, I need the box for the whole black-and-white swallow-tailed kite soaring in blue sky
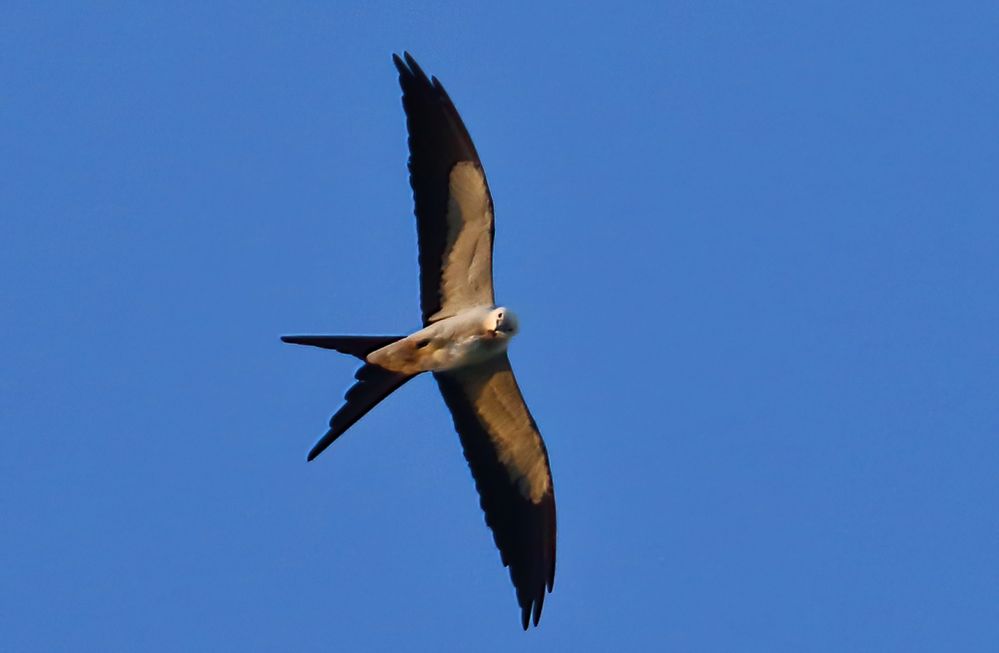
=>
[281,52,555,630]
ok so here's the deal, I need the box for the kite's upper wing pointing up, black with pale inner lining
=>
[392,52,494,324]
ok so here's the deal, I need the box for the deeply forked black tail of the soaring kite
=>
[281,336,415,460]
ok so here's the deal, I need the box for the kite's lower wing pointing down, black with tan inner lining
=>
[434,354,555,630]
